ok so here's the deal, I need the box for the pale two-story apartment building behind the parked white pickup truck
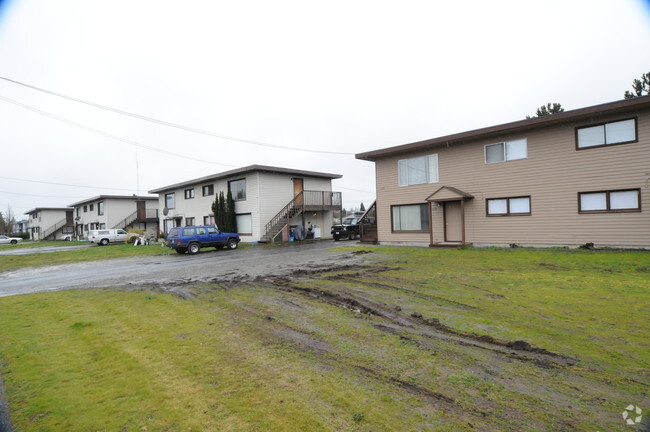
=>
[70,195,158,238]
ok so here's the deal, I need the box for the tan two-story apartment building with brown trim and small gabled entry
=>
[356,96,650,248]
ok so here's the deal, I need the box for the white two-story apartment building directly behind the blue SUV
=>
[149,165,341,242]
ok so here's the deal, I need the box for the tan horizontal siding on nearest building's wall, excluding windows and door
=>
[376,109,650,246]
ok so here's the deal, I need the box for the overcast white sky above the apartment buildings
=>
[0,0,650,219]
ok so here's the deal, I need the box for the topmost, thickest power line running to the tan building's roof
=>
[0,76,354,156]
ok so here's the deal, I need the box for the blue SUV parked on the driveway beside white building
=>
[167,226,240,255]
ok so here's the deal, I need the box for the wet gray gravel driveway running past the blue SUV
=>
[0,241,364,297]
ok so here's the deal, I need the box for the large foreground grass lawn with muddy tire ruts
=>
[0,247,650,432]
